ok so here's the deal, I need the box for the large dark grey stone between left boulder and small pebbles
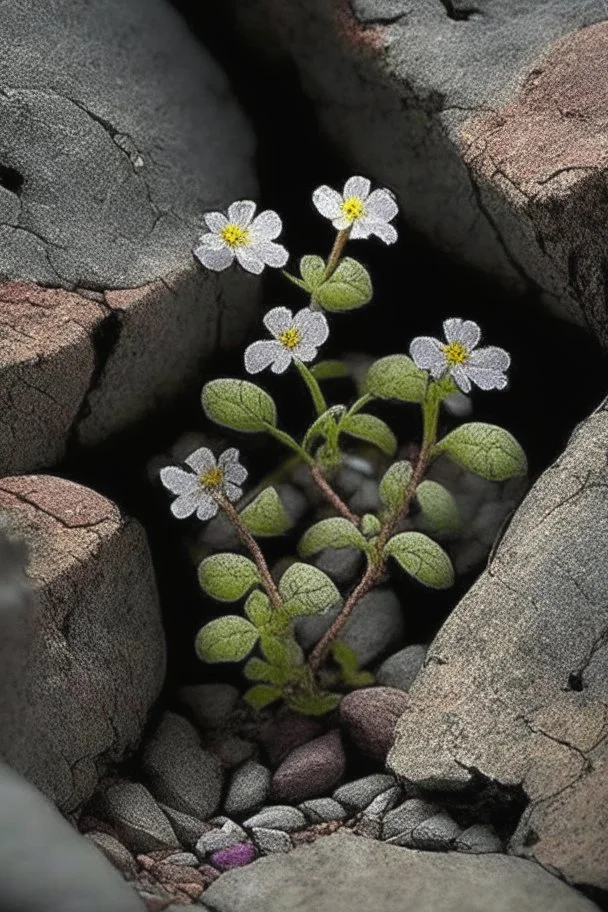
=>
[142,713,223,820]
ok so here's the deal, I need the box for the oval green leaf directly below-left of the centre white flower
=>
[202,379,277,432]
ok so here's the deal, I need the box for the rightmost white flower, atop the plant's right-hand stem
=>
[410,318,511,393]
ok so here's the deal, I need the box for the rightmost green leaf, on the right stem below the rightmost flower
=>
[433,422,528,481]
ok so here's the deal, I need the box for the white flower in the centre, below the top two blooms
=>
[245,307,329,374]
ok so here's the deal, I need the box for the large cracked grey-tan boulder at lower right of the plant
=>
[389,402,608,890]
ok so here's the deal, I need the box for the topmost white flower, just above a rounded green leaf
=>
[312,177,399,244]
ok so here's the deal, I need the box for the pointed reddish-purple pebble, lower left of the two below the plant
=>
[272,731,346,804]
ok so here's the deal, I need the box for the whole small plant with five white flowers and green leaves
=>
[161,177,526,715]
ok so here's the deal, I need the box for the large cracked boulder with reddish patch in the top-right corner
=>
[266,0,608,345]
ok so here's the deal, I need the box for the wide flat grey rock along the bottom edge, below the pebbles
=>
[205,833,598,912]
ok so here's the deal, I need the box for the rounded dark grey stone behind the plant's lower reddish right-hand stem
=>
[296,589,405,668]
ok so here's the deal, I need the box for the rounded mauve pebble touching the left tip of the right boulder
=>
[340,687,409,764]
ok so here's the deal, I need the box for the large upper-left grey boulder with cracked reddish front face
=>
[0,0,259,474]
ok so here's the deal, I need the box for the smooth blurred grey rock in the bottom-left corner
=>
[0,765,144,912]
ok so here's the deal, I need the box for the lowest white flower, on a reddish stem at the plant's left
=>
[160,447,247,520]
